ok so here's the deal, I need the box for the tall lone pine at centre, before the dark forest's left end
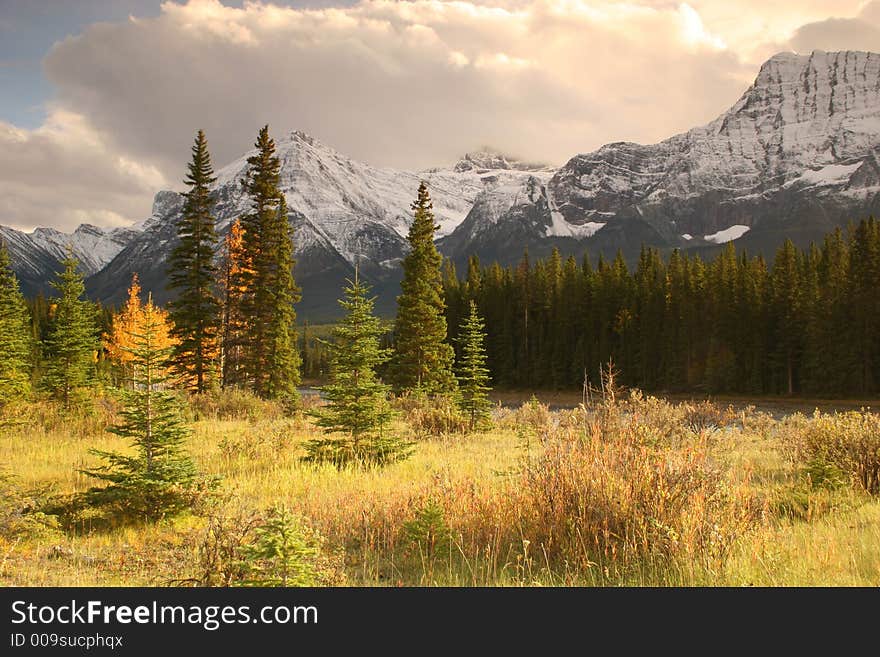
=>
[393,182,455,394]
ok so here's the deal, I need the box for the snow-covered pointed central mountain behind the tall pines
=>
[88,132,552,316]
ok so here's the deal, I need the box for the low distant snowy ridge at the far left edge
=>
[0,224,140,290]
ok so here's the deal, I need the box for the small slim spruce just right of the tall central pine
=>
[457,301,492,431]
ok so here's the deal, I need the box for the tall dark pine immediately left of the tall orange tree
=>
[168,130,220,393]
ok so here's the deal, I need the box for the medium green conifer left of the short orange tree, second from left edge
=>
[43,248,98,409]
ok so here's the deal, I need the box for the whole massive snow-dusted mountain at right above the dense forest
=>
[442,51,880,261]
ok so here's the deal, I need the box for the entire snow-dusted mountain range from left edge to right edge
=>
[0,51,880,321]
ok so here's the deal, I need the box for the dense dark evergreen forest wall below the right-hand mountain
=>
[444,218,880,395]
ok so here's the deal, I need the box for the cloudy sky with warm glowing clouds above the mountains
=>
[0,0,880,230]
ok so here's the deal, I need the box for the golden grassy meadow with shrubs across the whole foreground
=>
[0,386,880,586]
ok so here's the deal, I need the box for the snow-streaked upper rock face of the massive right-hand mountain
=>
[550,51,880,234]
